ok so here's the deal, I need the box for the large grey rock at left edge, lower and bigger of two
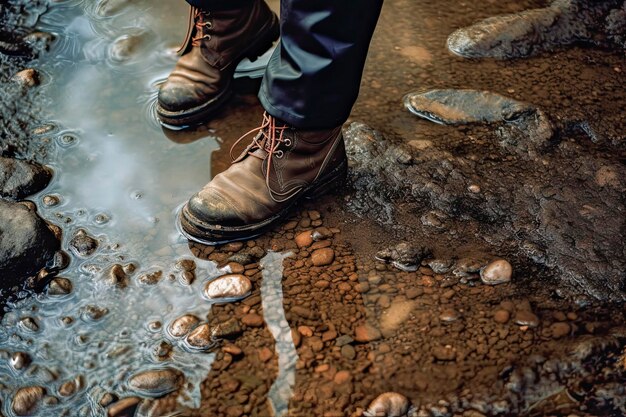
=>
[0,199,60,288]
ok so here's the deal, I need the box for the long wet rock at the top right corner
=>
[448,0,626,59]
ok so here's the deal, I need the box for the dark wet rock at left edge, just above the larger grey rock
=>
[0,156,52,199]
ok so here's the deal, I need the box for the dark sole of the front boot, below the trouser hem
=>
[176,161,348,246]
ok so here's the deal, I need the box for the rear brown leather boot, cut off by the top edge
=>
[157,0,280,126]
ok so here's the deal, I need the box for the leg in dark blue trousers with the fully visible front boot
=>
[179,0,382,243]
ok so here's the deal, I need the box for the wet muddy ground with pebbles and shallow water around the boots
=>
[0,0,626,417]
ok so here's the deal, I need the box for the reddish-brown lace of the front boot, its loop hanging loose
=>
[230,112,301,203]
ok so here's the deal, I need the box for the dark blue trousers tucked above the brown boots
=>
[187,0,383,129]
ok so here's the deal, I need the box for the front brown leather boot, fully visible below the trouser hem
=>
[179,114,348,245]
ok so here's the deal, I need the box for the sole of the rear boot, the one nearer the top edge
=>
[156,13,280,127]
